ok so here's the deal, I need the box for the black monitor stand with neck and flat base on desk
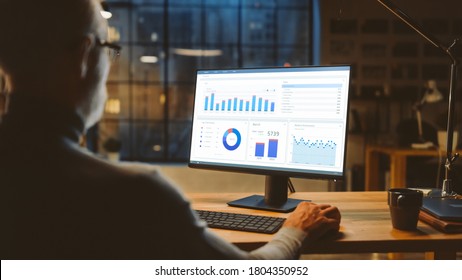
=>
[228,175,307,213]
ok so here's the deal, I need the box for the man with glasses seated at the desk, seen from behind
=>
[0,0,340,259]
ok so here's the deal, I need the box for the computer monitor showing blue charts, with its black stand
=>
[189,66,350,212]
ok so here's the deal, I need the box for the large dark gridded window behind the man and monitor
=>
[97,0,313,162]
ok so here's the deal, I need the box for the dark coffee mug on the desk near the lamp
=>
[388,188,423,230]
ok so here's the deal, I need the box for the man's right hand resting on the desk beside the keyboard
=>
[284,202,341,241]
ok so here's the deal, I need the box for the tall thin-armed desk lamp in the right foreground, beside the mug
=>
[377,0,462,197]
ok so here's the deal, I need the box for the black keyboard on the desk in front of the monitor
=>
[196,210,286,234]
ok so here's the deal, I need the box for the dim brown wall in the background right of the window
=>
[320,0,462,188]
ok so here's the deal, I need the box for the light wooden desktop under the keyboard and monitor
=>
[188,192,462,259]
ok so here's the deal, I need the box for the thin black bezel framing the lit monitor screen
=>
[188,64,352,183]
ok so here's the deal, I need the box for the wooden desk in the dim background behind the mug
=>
[365,146,461,191]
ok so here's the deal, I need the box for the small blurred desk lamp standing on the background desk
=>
[411,80,443,149]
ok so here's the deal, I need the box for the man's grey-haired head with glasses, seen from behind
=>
[0,0,109,127]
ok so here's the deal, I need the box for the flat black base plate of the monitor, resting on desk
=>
[228,195,309,213]
